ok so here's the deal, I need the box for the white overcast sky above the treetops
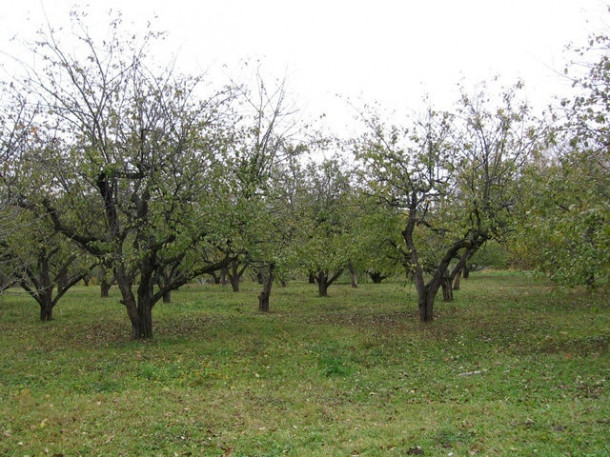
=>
[0,0,610,131]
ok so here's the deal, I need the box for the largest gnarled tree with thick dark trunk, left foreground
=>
[5,13,230,338]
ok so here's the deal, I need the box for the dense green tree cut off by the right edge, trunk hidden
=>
[513,35,610,289]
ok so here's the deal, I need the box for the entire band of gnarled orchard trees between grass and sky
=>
[0,8,610,338]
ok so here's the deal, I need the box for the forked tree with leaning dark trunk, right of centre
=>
[355,86,535,322]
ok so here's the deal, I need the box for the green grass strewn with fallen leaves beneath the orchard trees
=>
[0,273,610,457]
